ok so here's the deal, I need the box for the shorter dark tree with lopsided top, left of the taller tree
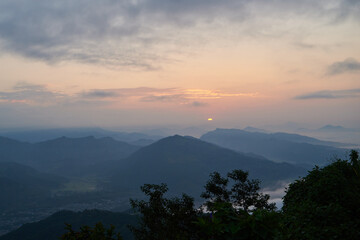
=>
[130,184,197,240]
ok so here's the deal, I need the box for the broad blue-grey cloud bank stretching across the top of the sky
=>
[0,0,360,71]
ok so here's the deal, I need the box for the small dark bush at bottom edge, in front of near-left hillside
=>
[60,222,122,240]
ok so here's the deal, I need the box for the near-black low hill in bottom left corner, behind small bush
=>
[0,210,137,240]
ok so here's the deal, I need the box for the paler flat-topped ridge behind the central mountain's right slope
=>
[201,129,346,166]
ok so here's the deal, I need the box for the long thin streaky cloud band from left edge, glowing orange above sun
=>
[0,82,258,107]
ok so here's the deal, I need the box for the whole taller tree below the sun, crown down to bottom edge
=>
[196,169,280,240]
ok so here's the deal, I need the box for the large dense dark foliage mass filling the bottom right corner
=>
[283,151,360,239]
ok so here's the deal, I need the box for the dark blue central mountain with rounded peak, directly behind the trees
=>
[113,135,305,196]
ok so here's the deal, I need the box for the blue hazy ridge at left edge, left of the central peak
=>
[0,137,139,176]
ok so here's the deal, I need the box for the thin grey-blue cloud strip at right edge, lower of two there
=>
[294,88,360,100]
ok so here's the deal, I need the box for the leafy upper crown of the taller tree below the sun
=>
[201,169,275,212]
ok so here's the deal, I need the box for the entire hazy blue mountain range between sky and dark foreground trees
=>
[0,129,352,239]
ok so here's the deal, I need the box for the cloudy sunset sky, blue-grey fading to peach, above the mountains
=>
[0,0,360,128]
